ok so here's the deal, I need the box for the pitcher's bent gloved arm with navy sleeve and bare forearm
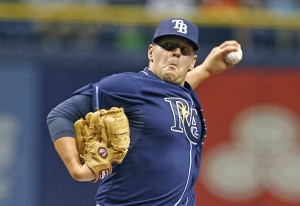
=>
[47,95,95,181]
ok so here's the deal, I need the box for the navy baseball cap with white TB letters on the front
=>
[152,18,199,51]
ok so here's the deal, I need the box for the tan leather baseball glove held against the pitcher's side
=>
[74,107,130,182]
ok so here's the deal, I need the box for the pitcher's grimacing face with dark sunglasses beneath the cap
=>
[148,36,197,86]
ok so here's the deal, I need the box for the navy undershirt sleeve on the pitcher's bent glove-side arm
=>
[47,95,93,142]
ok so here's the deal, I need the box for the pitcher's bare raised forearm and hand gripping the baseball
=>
[186,40,241,89]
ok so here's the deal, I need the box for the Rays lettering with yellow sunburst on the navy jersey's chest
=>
[165,97,200,144]
